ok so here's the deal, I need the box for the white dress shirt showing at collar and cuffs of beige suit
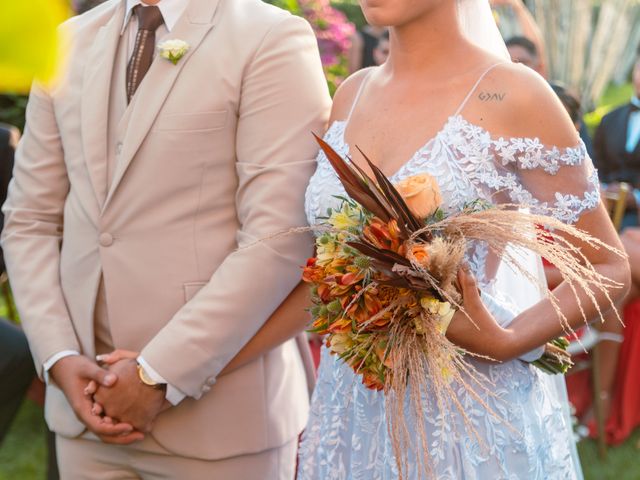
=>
[44,0,189,405]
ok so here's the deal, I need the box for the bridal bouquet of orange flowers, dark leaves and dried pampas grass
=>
[303,133,624,470]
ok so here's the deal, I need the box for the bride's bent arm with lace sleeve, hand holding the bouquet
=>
[447,66,630,360]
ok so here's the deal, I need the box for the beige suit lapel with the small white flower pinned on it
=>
[103,0,219,211]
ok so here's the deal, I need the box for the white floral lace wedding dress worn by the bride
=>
[298,109,599,480]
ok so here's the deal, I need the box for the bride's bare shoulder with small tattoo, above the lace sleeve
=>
[470,63,578,147]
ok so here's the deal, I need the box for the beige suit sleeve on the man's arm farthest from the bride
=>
[2,86,80,375]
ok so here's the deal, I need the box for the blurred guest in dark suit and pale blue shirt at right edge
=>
[595,52,640,227]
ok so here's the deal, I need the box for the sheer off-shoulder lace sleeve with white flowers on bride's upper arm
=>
[462,131,600,223]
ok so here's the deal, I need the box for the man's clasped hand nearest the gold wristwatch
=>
[92,357,168,432]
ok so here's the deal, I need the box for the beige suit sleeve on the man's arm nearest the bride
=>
[141,16,330,398]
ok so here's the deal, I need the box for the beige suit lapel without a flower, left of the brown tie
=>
[80,2,125,205]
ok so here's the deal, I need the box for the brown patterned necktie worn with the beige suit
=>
[127,5,164,102]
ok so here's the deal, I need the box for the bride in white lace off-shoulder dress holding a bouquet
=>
[298,0,628,480]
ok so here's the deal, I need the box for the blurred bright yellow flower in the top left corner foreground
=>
[0,0,70,92]
